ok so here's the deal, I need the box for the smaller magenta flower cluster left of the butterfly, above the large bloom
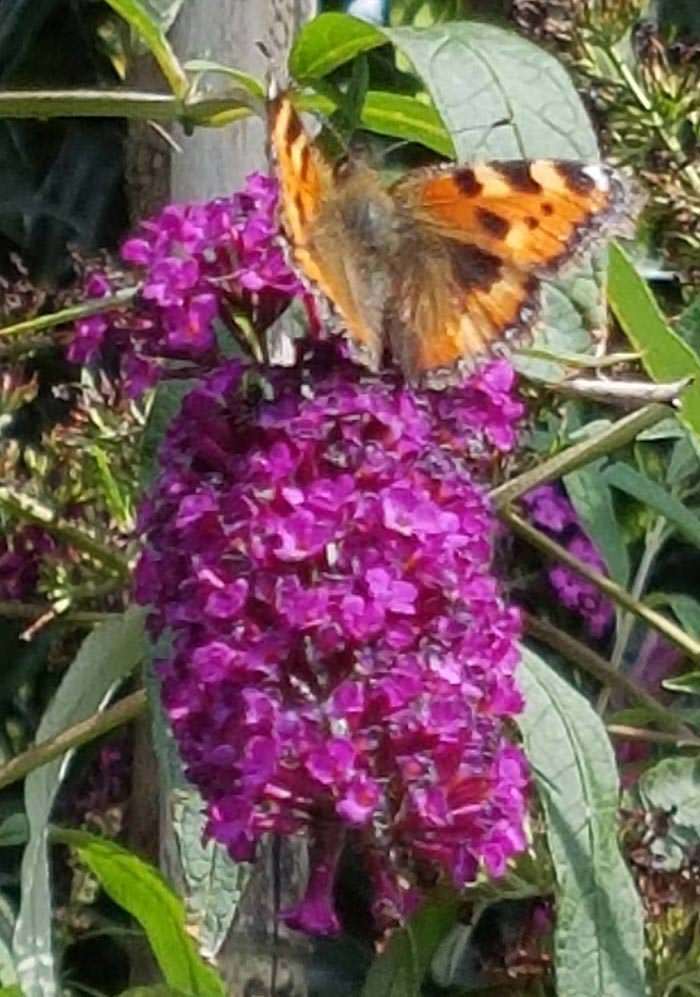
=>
[68,173,302,396]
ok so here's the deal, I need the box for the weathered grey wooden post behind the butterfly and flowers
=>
[127,0,317,997]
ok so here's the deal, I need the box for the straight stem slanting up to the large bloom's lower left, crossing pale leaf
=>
[0,689,147,789]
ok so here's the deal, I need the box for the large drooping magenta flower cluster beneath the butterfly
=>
[137,354,527,933]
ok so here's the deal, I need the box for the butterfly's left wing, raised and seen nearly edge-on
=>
[268,94,382,368]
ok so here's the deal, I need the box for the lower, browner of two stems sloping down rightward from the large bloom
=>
[524,613,700,744]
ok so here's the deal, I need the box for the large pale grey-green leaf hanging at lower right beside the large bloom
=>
[519,647,645,997]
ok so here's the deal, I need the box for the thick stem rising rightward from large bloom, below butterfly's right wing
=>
[489,404,673,509]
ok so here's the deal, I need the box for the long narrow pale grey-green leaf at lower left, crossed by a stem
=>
[13,609,147,997]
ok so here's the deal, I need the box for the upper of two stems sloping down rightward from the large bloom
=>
[508,509,700,661]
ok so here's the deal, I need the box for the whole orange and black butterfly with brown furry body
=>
[268,93,632,387]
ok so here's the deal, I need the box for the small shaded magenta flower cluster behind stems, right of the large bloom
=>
[523,484,615,637]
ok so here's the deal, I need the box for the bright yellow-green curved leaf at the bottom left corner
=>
[52,829,224,997]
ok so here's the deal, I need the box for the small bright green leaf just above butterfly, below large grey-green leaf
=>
[360,90,455,159]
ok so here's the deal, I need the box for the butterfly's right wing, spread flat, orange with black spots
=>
[390,160,630,380]
